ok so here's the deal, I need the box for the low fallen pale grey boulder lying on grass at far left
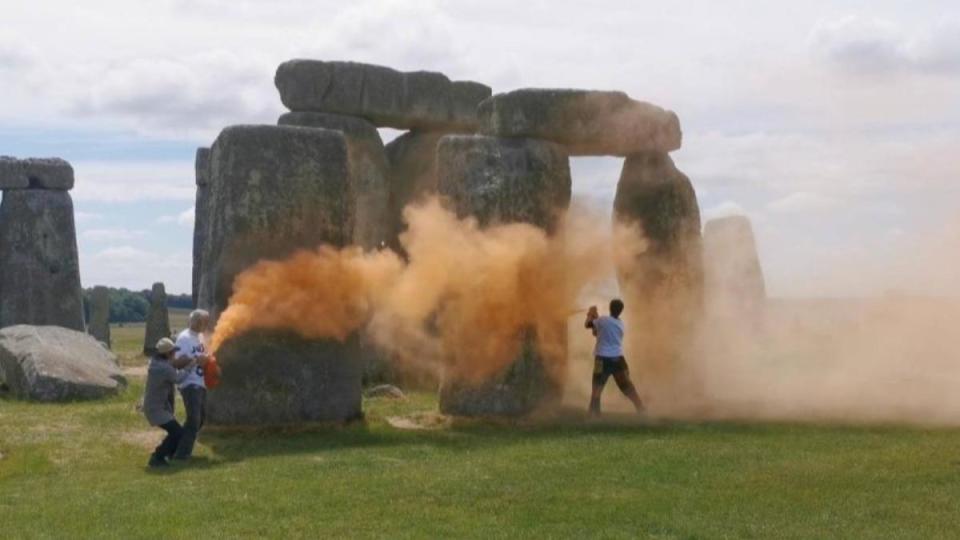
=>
[0,325,126,401]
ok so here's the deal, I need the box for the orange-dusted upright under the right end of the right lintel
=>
[614,153,703,400]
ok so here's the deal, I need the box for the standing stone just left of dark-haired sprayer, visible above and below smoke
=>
[437,135,571,416]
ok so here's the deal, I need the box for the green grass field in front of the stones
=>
[0,314,960,538]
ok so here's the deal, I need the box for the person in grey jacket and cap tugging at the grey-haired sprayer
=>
[143,338,206,468]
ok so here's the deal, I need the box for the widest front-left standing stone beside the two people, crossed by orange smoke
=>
[200,126,362,424]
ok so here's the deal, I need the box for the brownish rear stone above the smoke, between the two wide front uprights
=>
[386,131,450,253]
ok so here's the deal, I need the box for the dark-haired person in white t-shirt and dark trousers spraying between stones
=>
[584,299,643,416]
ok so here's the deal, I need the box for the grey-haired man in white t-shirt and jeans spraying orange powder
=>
[173,309,210,459]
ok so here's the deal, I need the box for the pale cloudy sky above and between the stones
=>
[0,0,960,296]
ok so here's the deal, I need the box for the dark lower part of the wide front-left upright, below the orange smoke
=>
[207,331,363,425]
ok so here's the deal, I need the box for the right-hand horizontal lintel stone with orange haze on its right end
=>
[478,88,682,156]
